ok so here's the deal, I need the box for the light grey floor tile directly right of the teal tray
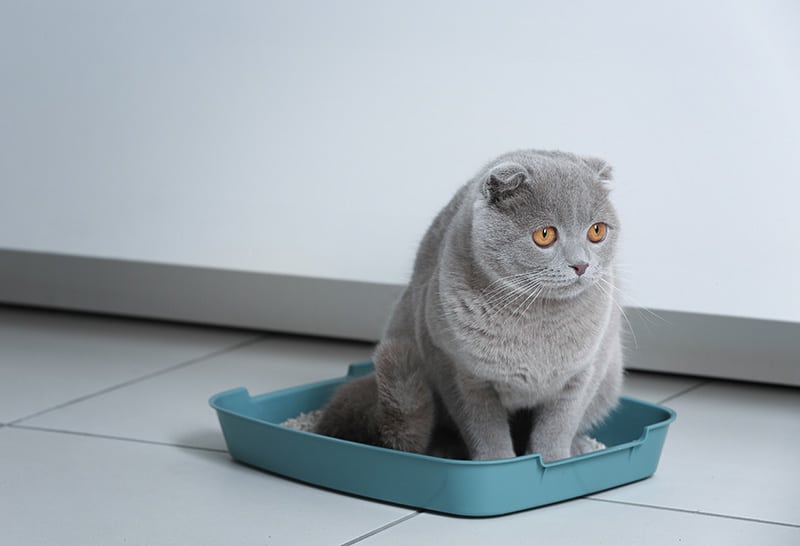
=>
[598,382,800,524]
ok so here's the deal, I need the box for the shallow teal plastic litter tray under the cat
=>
[209,362,675,516]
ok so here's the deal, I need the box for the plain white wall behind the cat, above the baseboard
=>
[0,0,800,322]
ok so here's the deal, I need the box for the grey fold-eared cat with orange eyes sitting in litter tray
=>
[315,150,623,461]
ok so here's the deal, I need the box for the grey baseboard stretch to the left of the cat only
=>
[0,250,402,341]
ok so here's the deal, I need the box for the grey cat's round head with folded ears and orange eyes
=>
[472,151,619,299]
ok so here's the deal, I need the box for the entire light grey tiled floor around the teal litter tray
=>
[0,307,800,546]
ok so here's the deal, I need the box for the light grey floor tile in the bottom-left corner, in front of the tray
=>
[0,427,412,546]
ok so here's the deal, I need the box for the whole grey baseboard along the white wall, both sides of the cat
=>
[0,249,800,386]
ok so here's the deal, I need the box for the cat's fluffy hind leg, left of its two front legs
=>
[374,338,435,453]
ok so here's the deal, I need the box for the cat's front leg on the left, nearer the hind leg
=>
[442,374,516,460]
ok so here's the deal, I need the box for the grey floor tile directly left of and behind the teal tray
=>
[24,336,372,449]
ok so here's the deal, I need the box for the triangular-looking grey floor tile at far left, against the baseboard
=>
[0,307,259,423]
